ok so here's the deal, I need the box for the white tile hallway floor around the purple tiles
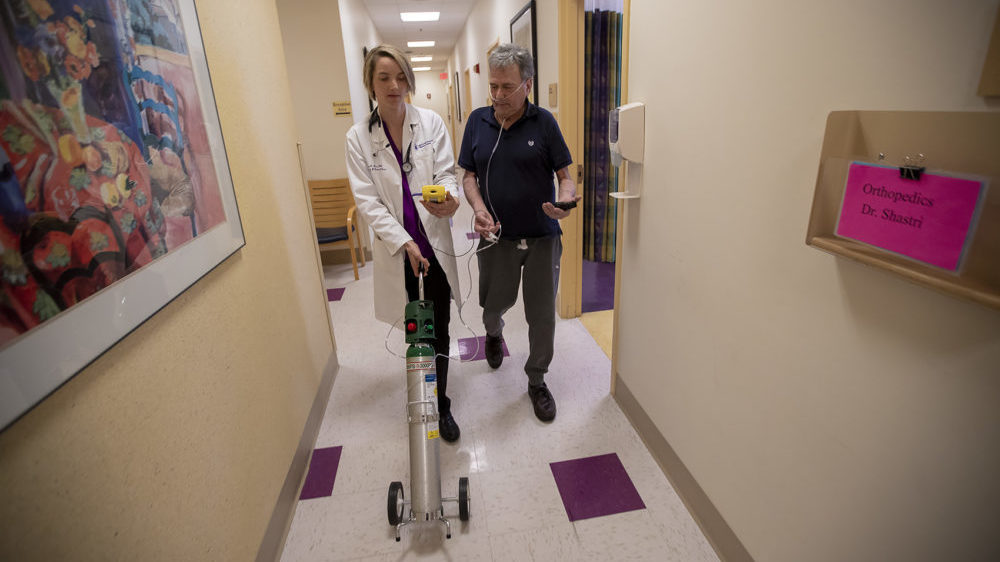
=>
[282,203,718,562]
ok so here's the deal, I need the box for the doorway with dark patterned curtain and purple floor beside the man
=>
[558,0,630,372]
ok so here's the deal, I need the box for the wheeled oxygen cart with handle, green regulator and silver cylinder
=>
[387,270,469,542]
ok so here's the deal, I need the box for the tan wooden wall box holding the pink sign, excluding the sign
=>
[806,111,1000,308]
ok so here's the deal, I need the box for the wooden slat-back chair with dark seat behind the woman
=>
[309,179,365,281]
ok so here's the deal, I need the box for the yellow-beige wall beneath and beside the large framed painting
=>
[0,0,332,560]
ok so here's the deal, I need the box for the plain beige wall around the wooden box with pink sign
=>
[618,0,1000,561]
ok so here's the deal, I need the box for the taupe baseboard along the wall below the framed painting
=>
[257,351,340,562]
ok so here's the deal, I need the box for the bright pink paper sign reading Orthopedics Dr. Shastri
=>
[837,162,983,271]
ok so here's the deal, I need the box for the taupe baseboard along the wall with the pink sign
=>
[614,376,753,562]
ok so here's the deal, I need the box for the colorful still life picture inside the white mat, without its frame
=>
[0,0,226,349]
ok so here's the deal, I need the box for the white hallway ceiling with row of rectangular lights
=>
[364,0,479,73]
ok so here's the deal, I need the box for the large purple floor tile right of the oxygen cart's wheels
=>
[549,453,646,521]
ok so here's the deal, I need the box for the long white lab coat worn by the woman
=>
[346,104,462,324]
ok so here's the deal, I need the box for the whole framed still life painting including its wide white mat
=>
[0,0,244,428]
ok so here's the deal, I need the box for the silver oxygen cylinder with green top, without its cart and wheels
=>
[406,343,441,521]
